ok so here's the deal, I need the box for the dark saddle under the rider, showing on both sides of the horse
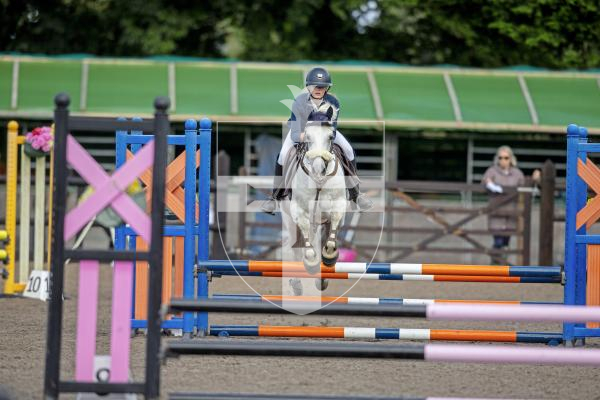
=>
[281,143,360,199]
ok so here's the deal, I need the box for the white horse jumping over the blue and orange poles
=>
[290,122,346,290]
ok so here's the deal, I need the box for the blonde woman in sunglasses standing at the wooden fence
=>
[481,146,540,263]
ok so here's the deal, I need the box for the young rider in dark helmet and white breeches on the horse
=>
[261,68,373,214]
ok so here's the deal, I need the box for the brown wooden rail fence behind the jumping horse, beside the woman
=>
[213,153,560,265]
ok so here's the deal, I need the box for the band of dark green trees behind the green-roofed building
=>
[0,0,600,68]
